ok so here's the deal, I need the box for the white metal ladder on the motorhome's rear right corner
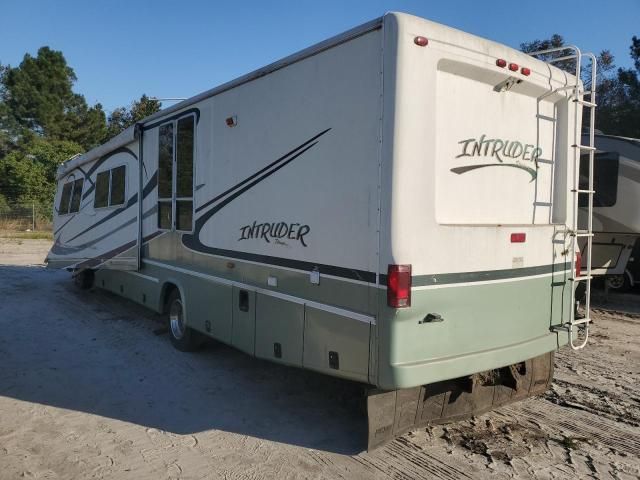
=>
[530,45,597,350]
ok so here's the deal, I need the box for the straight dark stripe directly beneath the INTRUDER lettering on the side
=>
[187,245,376,283]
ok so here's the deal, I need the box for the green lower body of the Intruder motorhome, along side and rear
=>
[90,255,571,390]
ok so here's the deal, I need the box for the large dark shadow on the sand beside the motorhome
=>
[0,266,366,454]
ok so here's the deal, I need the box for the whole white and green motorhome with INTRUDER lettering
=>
[48,13,595,448]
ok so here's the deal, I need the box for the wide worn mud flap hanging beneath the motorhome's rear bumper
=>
[367,352,554,450]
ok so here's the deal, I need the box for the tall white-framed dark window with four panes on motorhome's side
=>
[158,115,196,232]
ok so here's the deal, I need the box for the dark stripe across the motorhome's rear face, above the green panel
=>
[380,263,571,287]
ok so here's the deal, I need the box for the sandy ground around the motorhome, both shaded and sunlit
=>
[0,240,640,479]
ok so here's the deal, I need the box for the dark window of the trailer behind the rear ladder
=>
[579,152,620,207]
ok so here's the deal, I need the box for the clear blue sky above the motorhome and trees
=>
[0,0,640,113]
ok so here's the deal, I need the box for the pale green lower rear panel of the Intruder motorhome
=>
[376,272,571,389]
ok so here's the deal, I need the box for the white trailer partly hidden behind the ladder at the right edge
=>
[580,134,640,290]
